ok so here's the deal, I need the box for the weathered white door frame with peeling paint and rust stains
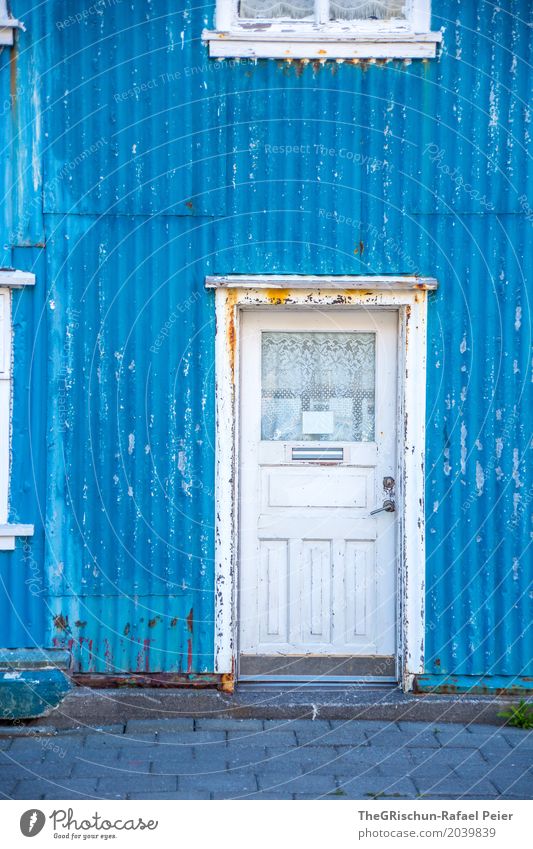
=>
[205,275,437,692]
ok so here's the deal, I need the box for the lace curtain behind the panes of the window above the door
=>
[239,0,405,21]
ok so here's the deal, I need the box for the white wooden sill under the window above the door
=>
[202,29,442,59]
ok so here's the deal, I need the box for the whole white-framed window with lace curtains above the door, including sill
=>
[204,0,441,59]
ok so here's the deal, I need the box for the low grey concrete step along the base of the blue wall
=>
[0,685,528,734]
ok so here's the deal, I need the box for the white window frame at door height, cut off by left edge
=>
[0,269,35,551]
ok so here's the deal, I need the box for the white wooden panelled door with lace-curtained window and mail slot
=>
[239,309,398,680]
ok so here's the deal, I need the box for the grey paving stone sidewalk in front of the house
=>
[0,718,533,800]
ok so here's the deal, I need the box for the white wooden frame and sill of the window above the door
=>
[203,0,441,60]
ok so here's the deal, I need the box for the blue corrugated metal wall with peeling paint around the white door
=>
[0,0,533,676]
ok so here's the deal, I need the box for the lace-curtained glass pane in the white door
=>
[261,333,376,442]
